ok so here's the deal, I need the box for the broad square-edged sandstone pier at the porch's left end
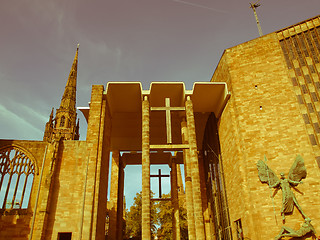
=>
[79,85,111,239]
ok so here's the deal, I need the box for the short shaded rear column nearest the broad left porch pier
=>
[108,150,120,239]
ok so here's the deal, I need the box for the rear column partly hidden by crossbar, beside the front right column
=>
[181,120,196,240]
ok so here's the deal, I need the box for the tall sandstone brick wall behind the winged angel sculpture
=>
[212,33,320,240]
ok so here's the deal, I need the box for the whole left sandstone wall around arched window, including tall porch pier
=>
[0,86,111,240]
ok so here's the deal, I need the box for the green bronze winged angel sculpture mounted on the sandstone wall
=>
[257,155,307,221]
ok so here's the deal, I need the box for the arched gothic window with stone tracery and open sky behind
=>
[0,146,35,209]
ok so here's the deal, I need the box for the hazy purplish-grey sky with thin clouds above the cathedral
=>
[0,0,320,208]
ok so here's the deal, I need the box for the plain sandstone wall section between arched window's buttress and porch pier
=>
[45,141,88,239]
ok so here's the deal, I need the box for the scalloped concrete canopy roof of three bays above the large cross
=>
[78,82,229,151]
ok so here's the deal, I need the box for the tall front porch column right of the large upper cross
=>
[185,96,206,240]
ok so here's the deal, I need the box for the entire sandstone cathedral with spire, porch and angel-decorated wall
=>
[0,16,320,240]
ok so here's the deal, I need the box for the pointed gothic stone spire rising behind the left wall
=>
[53,44,79,140]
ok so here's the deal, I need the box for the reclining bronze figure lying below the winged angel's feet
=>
[275,218,316,240]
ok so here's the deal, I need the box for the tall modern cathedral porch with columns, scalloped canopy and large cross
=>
[78,82,230,239]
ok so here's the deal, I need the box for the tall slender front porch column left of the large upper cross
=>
[142,96,151,240]
